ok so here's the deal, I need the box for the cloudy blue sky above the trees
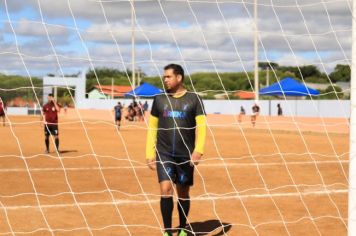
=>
[0,0,352,77]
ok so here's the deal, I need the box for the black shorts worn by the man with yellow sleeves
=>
[156,154,194,186]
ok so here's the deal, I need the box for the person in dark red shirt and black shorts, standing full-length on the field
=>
[42,93,60,153]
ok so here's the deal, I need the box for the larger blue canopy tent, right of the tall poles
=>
[260,77,320,97]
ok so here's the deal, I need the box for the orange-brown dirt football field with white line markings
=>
[0,111,349,235]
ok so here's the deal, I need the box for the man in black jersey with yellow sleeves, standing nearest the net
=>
[146,64,206,236]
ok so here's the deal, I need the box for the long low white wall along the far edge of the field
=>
[7,99,350,118]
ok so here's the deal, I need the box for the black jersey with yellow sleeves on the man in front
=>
[146,92,206,159]
